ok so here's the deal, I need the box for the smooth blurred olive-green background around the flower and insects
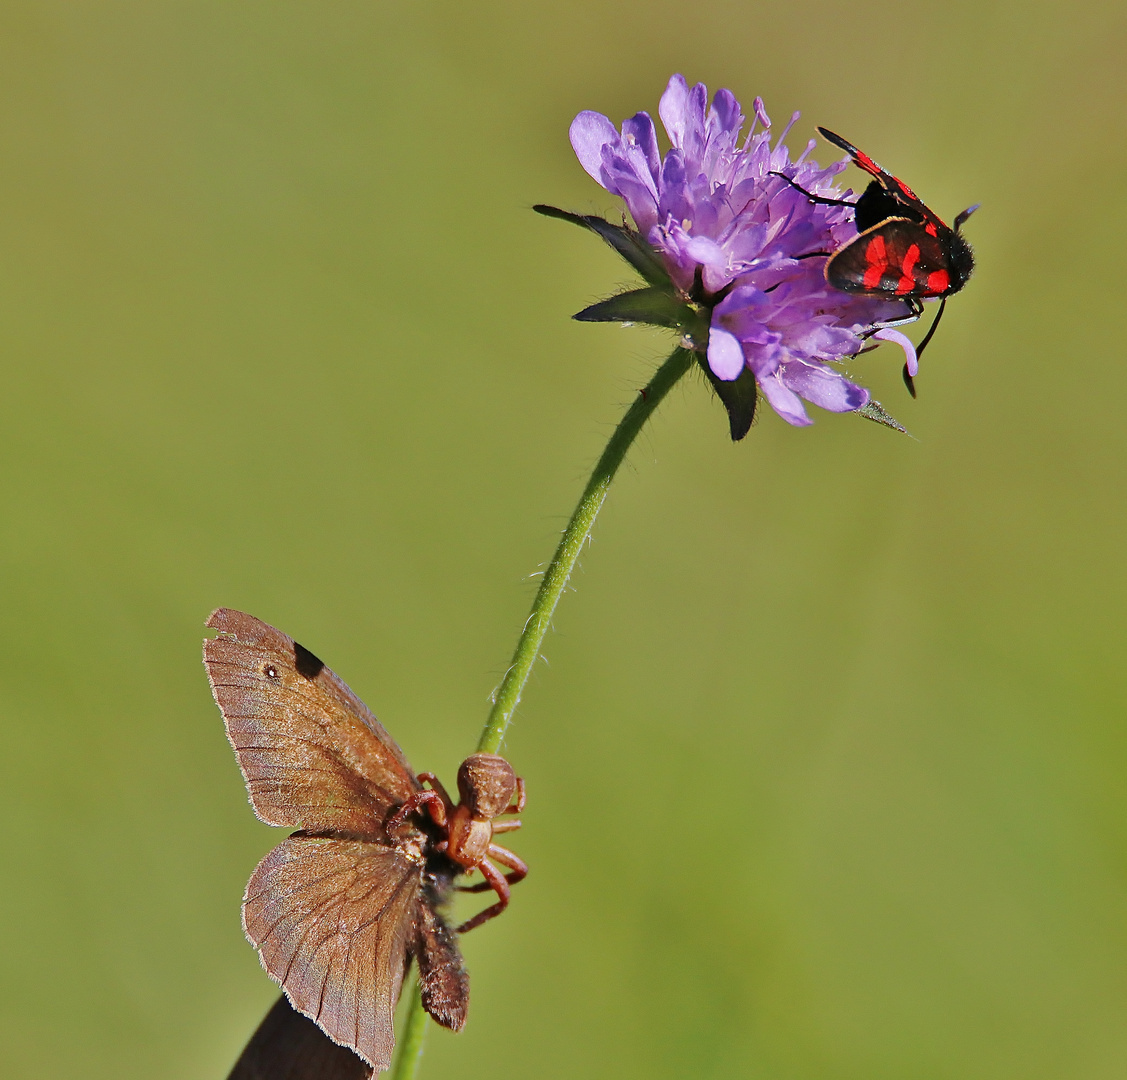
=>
[0,0,1127,1080]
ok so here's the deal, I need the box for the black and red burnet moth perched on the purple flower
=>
[790,127,978,397]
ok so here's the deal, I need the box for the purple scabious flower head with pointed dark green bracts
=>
[556,74,915,437]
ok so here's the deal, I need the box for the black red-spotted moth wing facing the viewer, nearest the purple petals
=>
[826,218,951,300]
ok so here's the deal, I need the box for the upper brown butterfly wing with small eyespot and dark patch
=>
[204,608,419,836]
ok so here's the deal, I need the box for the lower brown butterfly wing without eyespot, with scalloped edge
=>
[242,835,421,1070]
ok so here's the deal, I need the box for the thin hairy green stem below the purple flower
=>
[391,348,694,1080]
